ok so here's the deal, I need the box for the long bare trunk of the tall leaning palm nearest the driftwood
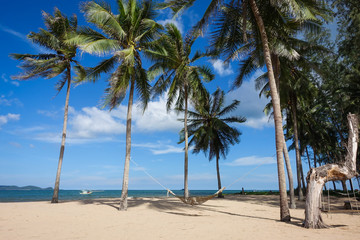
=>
[249,0,291,222]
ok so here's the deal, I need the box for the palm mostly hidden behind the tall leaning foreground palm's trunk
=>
[213,1,332,208]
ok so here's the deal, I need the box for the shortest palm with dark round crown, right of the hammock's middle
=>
[181,89,246,197]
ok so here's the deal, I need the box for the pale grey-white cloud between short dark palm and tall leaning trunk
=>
[226,70,273,129]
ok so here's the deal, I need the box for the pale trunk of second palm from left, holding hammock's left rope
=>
[119,80,135,211]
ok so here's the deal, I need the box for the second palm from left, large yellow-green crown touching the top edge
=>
[70,0,162,210]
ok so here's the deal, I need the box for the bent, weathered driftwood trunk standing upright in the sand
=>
[303,113,359,228]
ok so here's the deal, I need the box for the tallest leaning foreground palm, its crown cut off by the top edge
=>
[159,0,328,221]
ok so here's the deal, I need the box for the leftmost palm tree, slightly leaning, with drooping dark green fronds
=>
[10,8,83,203]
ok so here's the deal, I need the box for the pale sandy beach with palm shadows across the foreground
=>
[0,195,360,240]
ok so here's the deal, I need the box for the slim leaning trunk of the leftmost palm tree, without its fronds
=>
[51,67,71,203]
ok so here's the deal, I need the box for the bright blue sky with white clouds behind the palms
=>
[0,0,314,190]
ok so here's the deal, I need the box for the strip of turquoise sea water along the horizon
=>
[0,190,246,202]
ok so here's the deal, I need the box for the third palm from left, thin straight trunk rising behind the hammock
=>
[145,24,214,199]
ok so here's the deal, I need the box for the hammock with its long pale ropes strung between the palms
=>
[130,158,265,206]
